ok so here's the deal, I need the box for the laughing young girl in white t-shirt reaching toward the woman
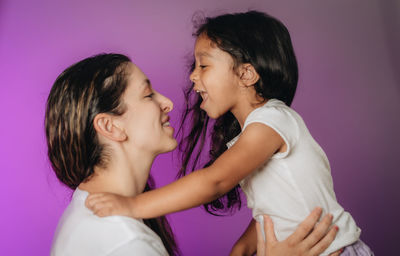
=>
[86,11,372,255]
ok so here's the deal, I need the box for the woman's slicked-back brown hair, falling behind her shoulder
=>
[45,54,179,255]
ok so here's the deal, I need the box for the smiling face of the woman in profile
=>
[120,63,177,155]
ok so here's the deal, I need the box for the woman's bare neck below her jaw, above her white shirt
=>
[79,149,154,196]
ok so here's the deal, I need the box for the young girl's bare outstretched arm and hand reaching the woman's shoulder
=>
[86,123,285,218]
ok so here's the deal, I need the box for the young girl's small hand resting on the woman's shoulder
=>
[85,193,134,218]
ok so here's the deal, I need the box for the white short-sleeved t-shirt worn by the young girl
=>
[227,99,361,255]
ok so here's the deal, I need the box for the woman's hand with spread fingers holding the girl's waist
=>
[256,208,342,256]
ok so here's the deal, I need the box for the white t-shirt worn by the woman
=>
[50,189,168,256]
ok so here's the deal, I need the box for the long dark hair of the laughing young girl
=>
[178,11,298,215]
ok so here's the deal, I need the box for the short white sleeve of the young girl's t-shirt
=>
[243,106,299,158]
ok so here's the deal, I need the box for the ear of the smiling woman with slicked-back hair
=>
[93,113,127,142]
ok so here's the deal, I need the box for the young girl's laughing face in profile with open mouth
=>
[190,35,239,118]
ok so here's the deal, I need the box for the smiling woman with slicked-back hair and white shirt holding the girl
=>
[45,54,335,256]
